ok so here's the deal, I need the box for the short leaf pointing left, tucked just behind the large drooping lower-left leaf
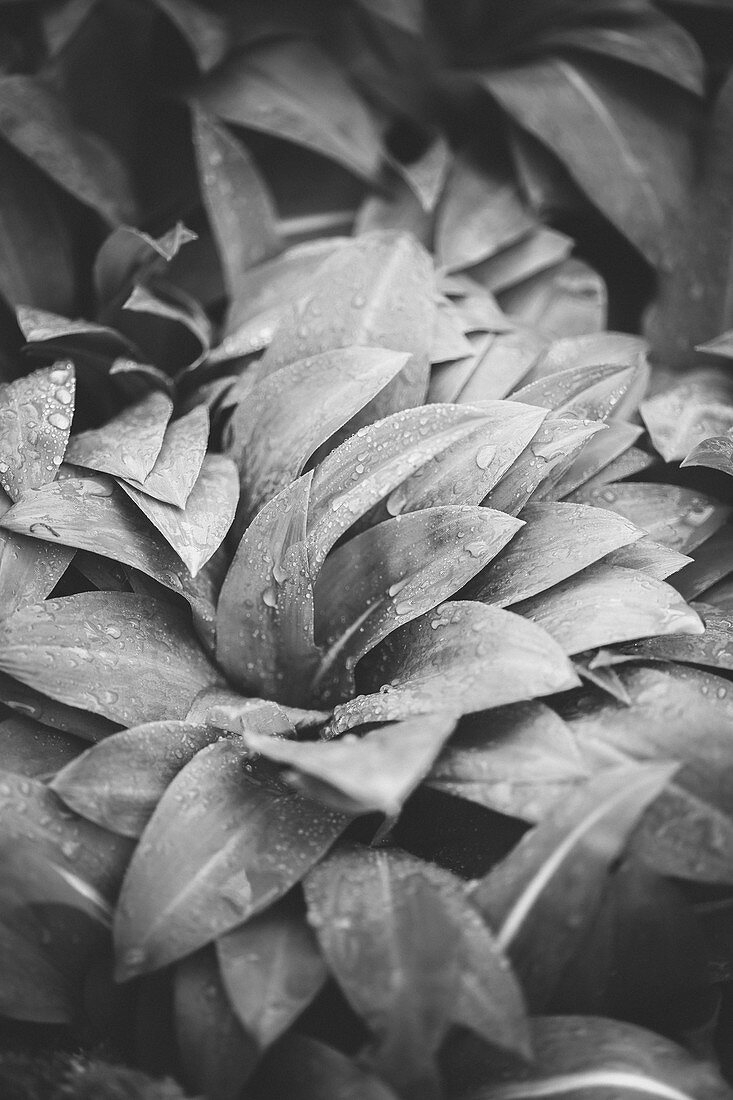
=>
[51,722,222,836]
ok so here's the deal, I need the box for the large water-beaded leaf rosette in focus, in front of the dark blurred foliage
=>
[0,207,733,1100]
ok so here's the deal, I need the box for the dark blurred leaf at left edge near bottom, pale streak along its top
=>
[0,840,109,1024]
